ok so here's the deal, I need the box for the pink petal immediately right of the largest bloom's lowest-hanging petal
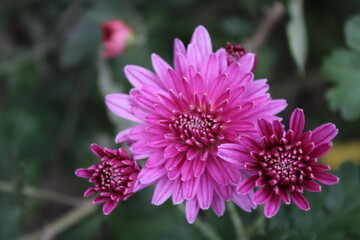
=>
[197,174,214,210]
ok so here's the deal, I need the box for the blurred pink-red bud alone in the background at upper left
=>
[101,20,132,58]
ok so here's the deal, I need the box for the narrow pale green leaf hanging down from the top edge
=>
[286,0,308,74]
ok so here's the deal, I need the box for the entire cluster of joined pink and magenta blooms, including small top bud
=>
[77,26,338,223]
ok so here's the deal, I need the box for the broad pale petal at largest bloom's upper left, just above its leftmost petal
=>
[124,65,159,88]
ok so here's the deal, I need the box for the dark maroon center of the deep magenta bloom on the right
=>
[258,143,314,191]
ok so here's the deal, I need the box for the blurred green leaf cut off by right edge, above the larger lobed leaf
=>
[345,14,360,53]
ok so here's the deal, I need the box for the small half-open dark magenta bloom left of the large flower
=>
[75,144,140,215]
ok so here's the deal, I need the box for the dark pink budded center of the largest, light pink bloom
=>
[169,110,224,148]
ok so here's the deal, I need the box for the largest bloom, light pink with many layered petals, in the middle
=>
[106,26,286,223]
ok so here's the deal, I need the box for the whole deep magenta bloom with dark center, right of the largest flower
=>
[219,109,339,217]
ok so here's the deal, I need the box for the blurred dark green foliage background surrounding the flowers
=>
[0,0,360,240]
